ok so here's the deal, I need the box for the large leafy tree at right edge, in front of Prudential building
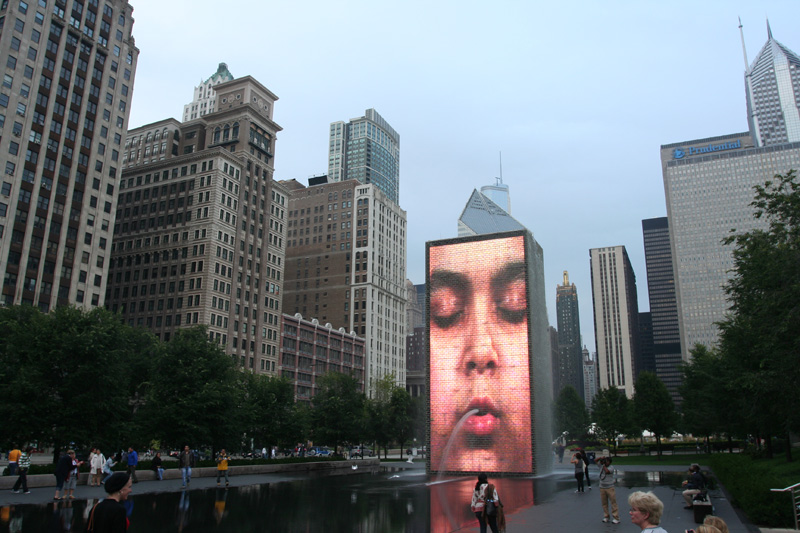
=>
[720,170,800,461]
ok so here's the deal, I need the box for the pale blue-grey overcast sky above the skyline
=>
[125,0,800,351]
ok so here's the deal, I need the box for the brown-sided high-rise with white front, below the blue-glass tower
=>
[281,178,407,392]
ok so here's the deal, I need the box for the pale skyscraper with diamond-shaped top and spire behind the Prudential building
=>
[739,21,800,146]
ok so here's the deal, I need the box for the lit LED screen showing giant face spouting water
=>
[427,235,533,473]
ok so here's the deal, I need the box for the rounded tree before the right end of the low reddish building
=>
[311,372,365,448]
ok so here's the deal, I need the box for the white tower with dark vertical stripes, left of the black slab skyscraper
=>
[589,246,639,398]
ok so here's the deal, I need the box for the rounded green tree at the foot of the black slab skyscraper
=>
[633,372,678,456]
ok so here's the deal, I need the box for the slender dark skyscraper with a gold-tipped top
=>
[553,270,586,399]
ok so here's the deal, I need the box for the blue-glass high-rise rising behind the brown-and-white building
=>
[328,109,400,204]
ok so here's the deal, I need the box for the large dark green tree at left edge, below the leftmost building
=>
[0,306,157,458]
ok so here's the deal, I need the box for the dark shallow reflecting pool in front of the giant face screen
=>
[0,466,685,533]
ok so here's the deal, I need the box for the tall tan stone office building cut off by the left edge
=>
[0,0,139,312]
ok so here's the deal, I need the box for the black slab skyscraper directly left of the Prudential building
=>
[642,217,682,404]
